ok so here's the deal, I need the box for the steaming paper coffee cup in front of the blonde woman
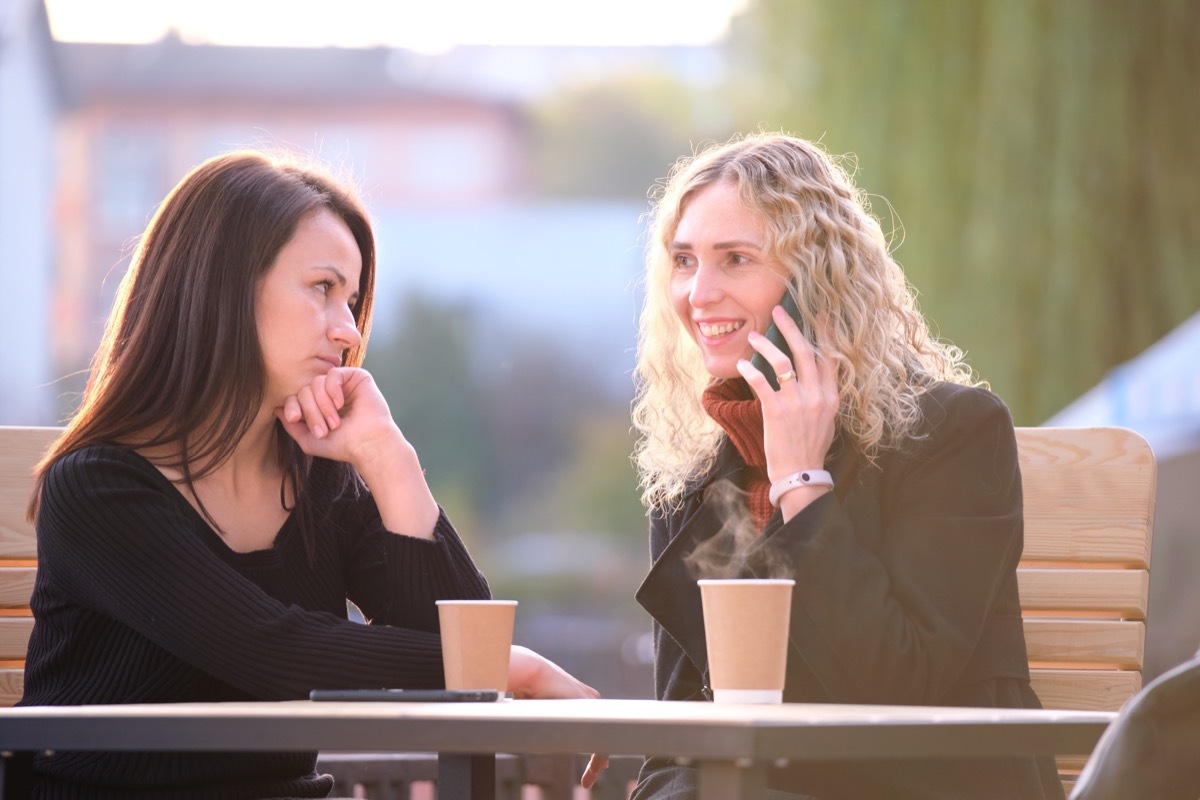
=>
[697,578,796,703]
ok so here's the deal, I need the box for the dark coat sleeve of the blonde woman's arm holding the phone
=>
[764,386,1025,704]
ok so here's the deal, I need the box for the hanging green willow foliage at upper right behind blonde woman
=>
[734,0,1200,425]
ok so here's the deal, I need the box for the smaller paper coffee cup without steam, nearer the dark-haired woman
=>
[437,600,517,697]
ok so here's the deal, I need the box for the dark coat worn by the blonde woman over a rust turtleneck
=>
[634,384,1063,800]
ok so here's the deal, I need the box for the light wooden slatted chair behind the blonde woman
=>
[1016,428,1156,789]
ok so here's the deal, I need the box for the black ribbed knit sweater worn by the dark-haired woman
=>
[20,446,490,800]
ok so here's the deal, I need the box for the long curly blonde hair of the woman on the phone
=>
[632,133,977,510]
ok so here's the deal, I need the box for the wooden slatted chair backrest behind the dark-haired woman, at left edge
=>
[0,427,62,706]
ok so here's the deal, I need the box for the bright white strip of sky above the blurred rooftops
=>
[46,0,749,53]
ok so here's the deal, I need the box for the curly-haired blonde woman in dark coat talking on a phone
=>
[634,134,1062,800]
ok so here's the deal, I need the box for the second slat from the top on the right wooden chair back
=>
[1016,567,1150,619]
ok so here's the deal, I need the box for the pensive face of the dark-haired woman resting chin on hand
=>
[254,210,362,408]
